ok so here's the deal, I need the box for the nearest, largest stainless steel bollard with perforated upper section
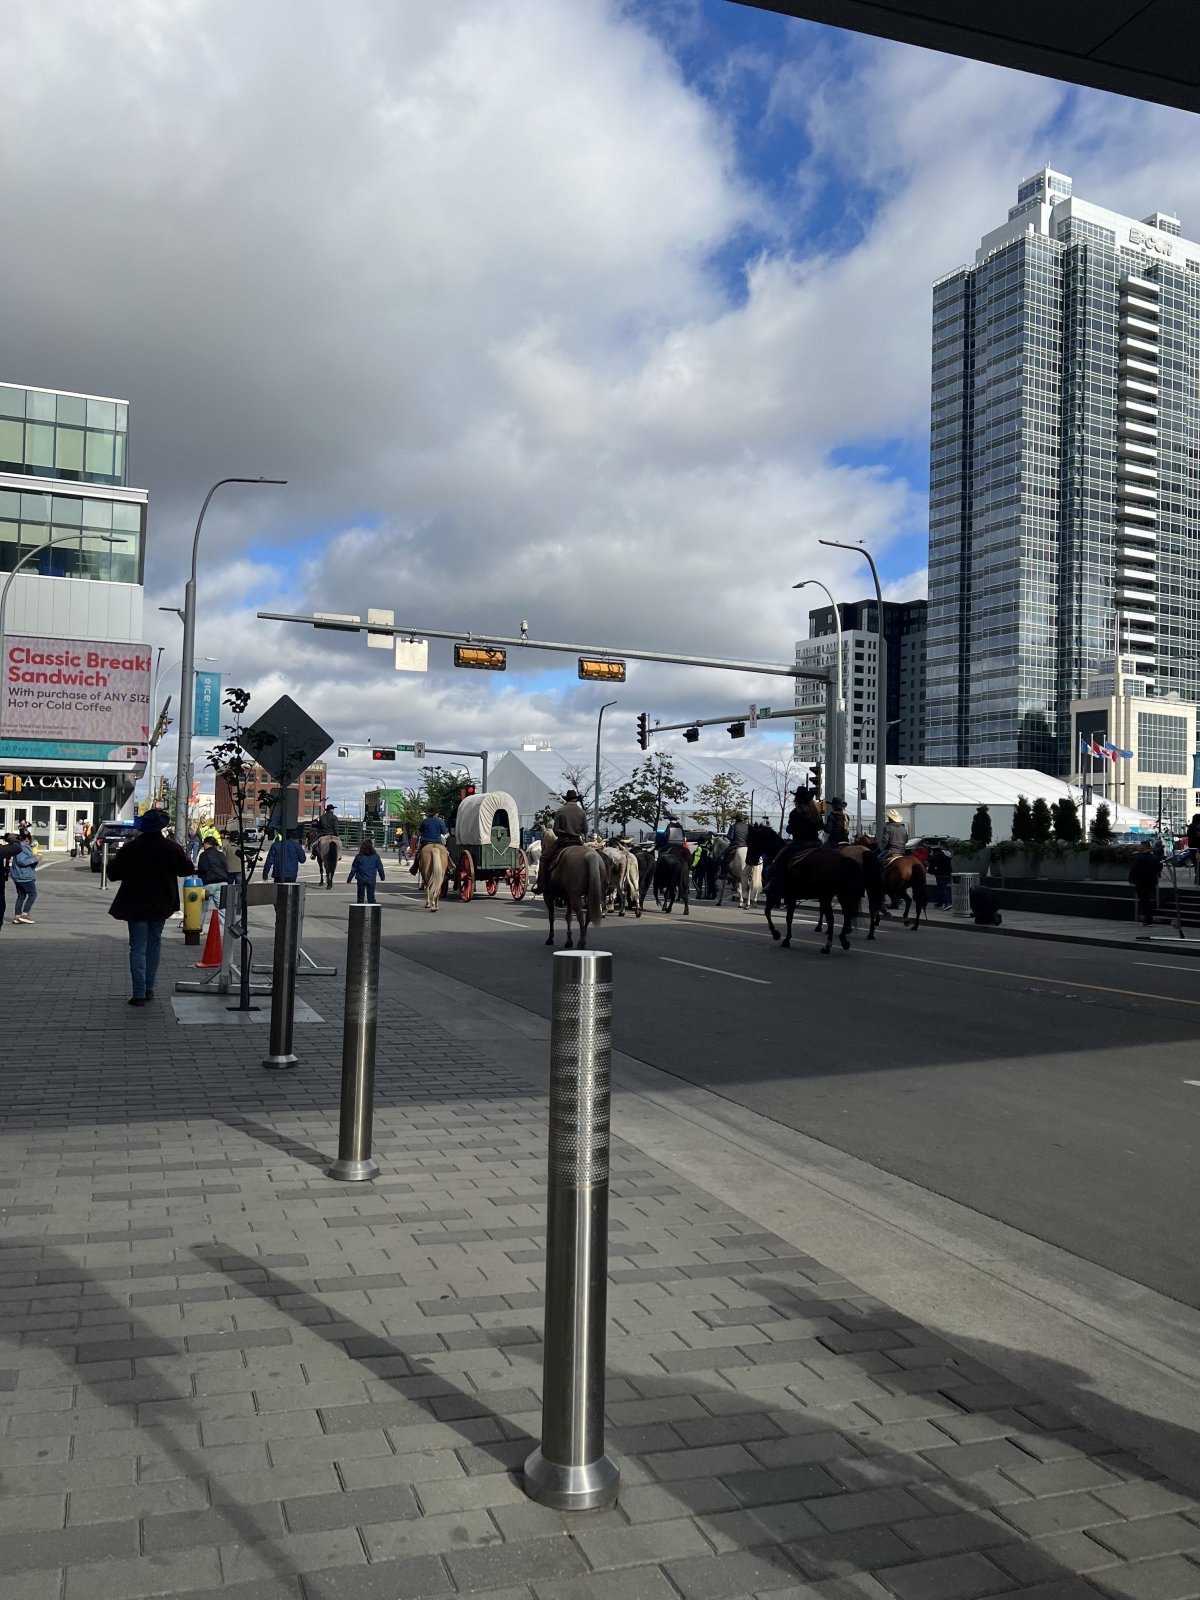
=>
[525,950,621,1510]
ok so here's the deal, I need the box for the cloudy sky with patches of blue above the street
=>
[9,0,1200,797]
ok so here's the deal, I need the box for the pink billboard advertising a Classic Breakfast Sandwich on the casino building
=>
[0,634,152,762]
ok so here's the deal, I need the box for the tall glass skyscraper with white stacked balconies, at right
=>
[926,168,1200,774]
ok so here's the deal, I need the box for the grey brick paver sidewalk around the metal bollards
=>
[0,866,1200,1600]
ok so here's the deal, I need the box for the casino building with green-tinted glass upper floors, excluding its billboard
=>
[0,382,149,848]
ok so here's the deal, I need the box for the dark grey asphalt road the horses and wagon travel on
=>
[302,872,1200,1307]
